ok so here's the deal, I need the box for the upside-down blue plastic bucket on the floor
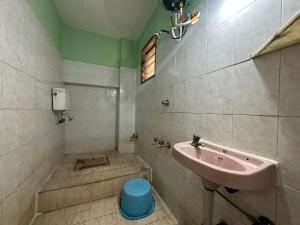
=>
[120,178,155,220]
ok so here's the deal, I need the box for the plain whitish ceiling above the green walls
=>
[54,0,158,41]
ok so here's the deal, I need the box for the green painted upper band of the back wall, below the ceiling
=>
[62,25,137,68]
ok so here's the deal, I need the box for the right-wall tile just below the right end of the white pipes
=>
[186,36,207,78]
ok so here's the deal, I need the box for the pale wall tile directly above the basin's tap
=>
[186,113,205,140]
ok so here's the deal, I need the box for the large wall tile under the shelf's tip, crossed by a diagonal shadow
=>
[233,53,279,115]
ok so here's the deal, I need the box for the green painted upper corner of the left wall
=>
[27,0,62,52]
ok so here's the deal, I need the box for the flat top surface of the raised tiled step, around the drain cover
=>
[42,151,150,192]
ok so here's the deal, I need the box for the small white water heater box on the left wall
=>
[52,88,70,111]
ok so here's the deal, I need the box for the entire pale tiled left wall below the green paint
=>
[0,0,63,225]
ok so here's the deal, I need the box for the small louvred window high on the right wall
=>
[141,37,156,83]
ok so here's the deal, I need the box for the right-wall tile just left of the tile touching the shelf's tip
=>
[207,19,235,72]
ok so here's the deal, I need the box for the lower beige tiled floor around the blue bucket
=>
[33,195,177,225]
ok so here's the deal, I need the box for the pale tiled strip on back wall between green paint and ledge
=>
[63,59,119,87]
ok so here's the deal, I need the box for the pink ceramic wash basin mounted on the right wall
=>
[172,139,277,190]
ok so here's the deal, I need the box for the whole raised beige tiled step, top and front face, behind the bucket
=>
[38,152,152,213]
